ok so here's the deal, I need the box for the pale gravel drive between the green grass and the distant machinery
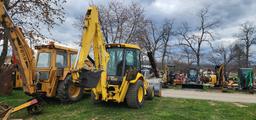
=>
[162,89,256,103]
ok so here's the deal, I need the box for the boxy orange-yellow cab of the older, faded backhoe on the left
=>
[35,43,77,82]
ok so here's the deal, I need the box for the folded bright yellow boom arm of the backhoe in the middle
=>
[72,6,109,98]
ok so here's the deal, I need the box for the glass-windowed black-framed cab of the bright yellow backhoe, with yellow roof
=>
[107,44,141,83]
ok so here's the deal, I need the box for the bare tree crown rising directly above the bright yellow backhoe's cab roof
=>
[99,0,145,43]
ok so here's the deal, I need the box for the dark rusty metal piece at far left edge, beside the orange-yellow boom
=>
[0,65,15,96]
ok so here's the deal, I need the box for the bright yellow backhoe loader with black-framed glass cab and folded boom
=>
[72,6,154,108]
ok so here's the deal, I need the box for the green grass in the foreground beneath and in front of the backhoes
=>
[0,90,256,120]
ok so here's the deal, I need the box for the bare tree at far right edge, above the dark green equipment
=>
[236,22,256,67]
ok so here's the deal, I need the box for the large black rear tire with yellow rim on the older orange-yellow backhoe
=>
[56,75,83,103]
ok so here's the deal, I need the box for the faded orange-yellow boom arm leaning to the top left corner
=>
[0,0,35,95]
